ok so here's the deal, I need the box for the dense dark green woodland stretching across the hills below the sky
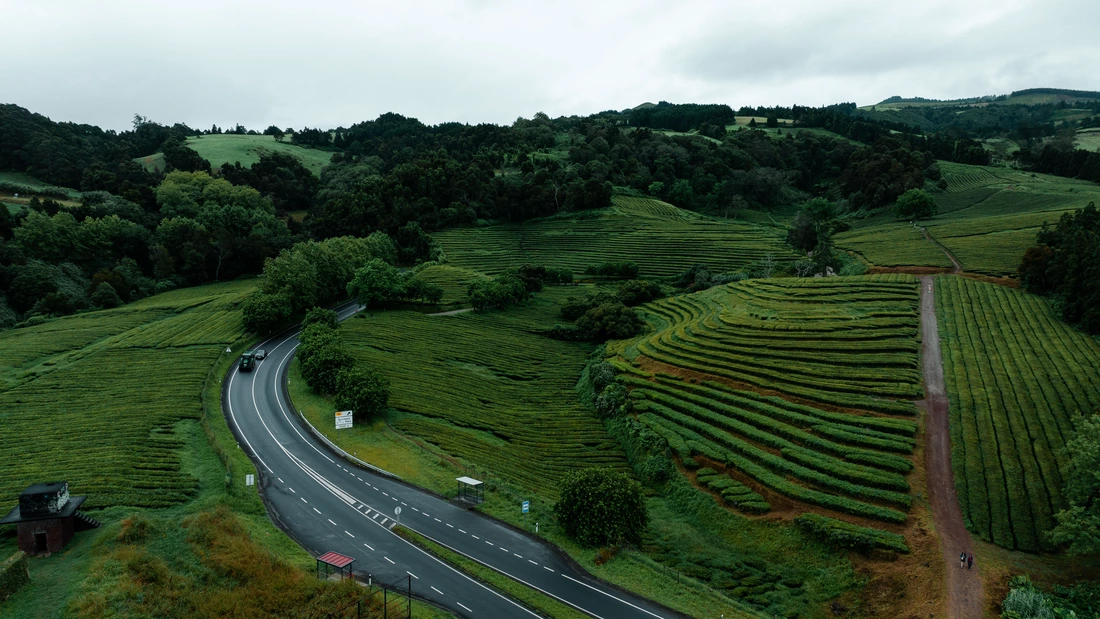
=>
[0,96,1100,325]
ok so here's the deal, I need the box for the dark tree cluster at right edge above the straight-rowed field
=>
[1020,202,1100,334]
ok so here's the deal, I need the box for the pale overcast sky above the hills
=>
[0,0,1100,130]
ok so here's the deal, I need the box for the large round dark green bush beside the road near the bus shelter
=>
[553,468,649,546]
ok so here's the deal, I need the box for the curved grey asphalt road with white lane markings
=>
[222,305,679,619]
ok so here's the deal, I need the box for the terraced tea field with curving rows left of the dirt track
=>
[608,275,921,523]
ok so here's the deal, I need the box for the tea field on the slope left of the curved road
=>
[0,283,254,509]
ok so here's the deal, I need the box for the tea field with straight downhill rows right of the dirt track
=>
[936,277,1100,551]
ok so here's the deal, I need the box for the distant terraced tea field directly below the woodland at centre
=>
[433,196,798,277]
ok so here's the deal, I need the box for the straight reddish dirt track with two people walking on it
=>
[917,278,985,619]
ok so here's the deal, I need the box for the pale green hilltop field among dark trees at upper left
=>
[134,134,332,176]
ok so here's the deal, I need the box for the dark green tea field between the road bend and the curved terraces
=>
[341,287,627,496]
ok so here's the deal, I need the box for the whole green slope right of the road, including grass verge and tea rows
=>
[290,283,858,617]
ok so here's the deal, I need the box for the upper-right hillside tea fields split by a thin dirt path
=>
[835,162,1100,276]
